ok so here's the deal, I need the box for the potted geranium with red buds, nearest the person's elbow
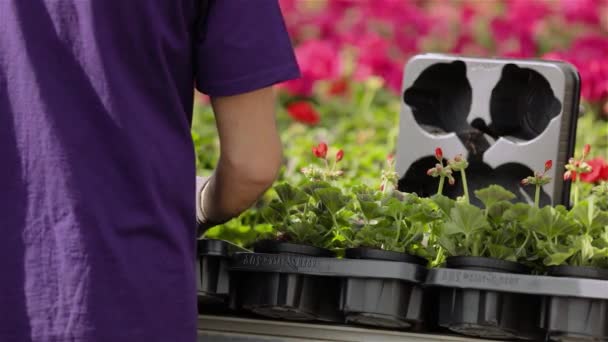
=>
[232,143,351,321]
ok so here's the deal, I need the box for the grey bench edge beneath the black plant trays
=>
[198,316,490,342]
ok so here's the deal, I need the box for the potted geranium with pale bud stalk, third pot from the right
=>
[341,157,441,329]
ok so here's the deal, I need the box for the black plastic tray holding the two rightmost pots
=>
[426,262,608,341]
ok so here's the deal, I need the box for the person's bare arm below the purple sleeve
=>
[201,87,282,231]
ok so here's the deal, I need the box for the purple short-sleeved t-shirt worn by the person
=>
[0,0,298,342]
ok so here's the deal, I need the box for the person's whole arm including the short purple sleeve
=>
[195,0,300,233]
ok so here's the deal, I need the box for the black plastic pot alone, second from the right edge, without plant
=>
[437,256,543,340]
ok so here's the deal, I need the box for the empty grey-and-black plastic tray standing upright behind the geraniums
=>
[396,54,580,205]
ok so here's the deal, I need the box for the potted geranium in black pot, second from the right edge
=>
[429,148,540,339]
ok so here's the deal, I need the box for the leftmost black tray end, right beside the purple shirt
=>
[196,239,246,313]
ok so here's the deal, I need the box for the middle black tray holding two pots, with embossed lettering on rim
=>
[230,242,426,328]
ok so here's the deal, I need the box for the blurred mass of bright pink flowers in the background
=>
[280,0,608,115]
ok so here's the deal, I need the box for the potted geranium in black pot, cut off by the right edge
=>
[524,168,608,340]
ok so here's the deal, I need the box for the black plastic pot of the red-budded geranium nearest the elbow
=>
[231,240,343,322]
